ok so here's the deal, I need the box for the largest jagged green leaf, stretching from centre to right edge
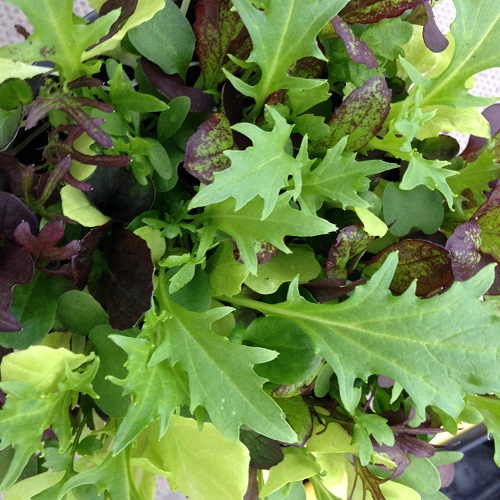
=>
[229,254,500,421]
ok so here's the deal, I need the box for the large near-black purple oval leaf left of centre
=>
[89,229,154,330]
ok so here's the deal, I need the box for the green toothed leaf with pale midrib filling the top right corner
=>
[423,0,500,108]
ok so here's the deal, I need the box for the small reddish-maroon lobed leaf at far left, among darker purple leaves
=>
[14,221,80,262]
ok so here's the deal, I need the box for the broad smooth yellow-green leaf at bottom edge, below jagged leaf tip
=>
[146,415,250,500]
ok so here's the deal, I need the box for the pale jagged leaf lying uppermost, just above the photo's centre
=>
[189,107,302,219]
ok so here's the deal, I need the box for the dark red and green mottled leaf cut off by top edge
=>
[340,0,424,24]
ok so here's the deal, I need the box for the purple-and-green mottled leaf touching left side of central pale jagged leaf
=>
[184,112,234,184]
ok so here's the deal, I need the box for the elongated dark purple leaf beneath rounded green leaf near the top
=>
[141,57,214,113]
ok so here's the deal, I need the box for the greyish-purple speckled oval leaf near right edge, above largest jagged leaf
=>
[446,220,481,281]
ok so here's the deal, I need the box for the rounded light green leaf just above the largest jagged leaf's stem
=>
[245,245,321,295]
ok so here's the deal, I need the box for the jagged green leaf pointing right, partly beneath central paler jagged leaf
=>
[198,195,337,274]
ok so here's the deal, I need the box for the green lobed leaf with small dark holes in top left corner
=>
[0,0,120,81]
